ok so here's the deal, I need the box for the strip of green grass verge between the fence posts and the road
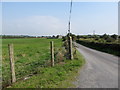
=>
[10,51,85,88]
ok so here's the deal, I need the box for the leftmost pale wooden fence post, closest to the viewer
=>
[8,44,16,83]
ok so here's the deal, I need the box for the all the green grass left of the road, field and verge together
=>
[2,38,84,88]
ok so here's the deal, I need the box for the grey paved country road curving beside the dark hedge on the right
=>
[73,43,118,88]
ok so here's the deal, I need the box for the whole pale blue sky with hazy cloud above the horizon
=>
[2,2,118,36]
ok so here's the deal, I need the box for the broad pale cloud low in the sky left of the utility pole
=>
[2,16,67,35]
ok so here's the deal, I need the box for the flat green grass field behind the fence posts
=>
[2,38,62,87]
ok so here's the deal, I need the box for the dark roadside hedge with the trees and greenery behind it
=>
[63,33,120,56]
